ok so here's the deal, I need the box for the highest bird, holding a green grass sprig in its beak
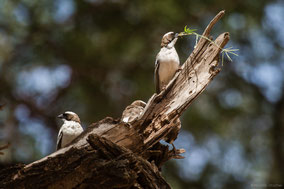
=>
[155,32,180,94]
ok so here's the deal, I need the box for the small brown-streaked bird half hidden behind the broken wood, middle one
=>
[121,100,146,123]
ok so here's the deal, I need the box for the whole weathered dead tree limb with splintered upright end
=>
[0,11,229,188]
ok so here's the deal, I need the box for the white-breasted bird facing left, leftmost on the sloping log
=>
[56,111,83,150]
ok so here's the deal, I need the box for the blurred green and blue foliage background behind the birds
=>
[0,0,284,189]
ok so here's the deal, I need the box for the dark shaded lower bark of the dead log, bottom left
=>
[1,134,170,188]
